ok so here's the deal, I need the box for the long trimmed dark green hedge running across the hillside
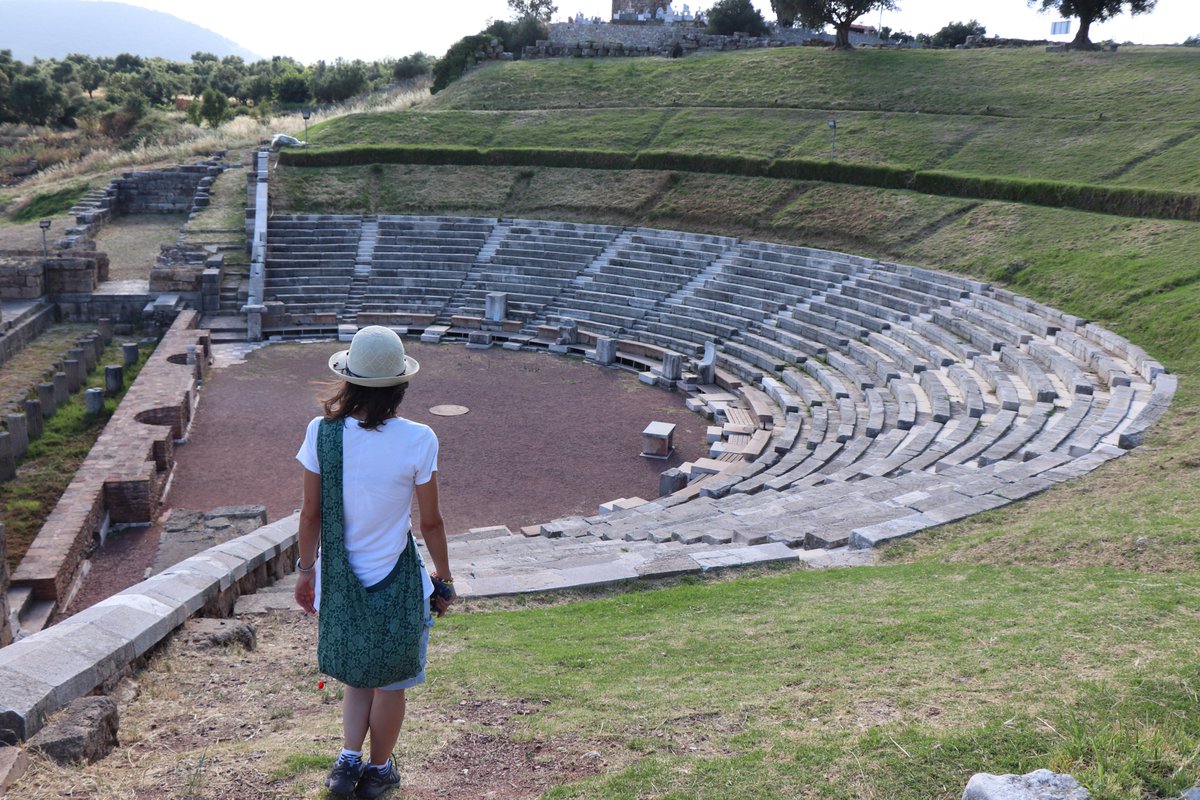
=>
[280,144,1200,221]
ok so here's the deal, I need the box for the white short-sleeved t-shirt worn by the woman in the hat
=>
[296,416,438,604]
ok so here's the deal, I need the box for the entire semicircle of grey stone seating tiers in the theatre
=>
[260,216,1175,587]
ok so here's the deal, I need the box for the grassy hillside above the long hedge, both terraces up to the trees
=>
[311,48,1200,188]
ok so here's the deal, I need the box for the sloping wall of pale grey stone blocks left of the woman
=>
[0,515,298,741]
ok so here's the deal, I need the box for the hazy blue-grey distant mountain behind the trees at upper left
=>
[0,0,259,64]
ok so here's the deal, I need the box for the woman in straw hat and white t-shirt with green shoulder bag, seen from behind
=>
[295,325,455,798]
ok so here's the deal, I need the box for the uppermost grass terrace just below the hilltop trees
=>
[433,48,1200,124]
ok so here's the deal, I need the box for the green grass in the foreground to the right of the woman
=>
[431,563,1200,799]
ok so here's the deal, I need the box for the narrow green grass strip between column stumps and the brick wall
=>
[0,342,152,570]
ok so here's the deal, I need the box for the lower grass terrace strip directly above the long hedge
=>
[311,108,1200,188]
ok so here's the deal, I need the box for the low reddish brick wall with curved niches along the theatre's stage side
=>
[12,311,210,607]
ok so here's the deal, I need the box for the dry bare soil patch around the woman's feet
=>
[8,613,605,800]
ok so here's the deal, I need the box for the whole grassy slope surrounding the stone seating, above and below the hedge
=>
[265,49,1200,800]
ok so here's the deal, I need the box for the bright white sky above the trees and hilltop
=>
[88,0,1200,64]
